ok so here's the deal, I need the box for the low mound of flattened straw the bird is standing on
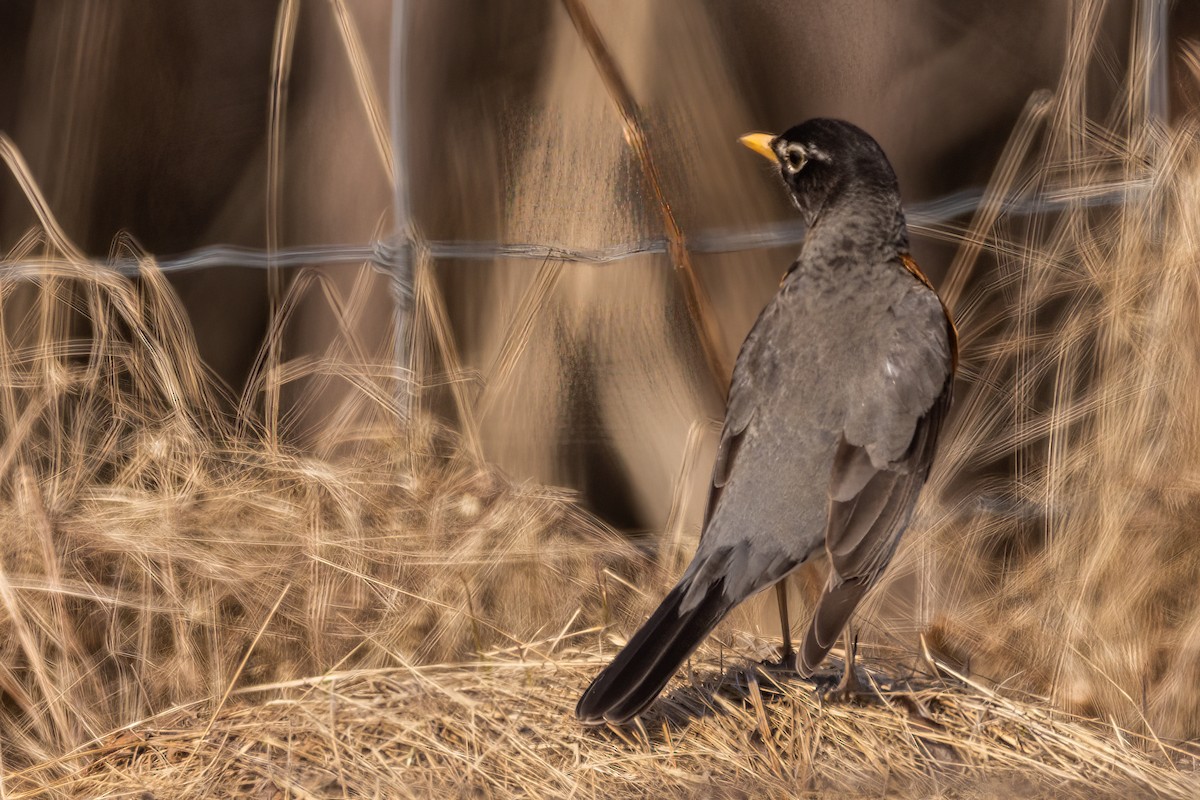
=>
[8,642,1200,798]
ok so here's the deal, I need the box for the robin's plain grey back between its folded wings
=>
[694,257,916,596]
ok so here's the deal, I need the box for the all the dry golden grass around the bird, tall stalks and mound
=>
[7,4,1200,798]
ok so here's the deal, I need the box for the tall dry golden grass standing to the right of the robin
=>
[924,25,1200,739]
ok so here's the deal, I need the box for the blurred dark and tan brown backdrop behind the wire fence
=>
[0,0,1200,563]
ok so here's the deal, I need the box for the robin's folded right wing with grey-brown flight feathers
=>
[797,281,956,674]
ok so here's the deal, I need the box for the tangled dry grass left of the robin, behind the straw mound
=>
[0,224,643,775]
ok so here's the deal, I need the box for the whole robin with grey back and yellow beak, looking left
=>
[575,119,958,724]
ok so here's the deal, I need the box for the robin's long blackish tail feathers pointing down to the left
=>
[575,581,731,724]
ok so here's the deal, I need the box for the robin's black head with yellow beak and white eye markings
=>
[739,119,900,227]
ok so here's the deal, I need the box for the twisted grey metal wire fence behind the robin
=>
[0,0,1169,522]
